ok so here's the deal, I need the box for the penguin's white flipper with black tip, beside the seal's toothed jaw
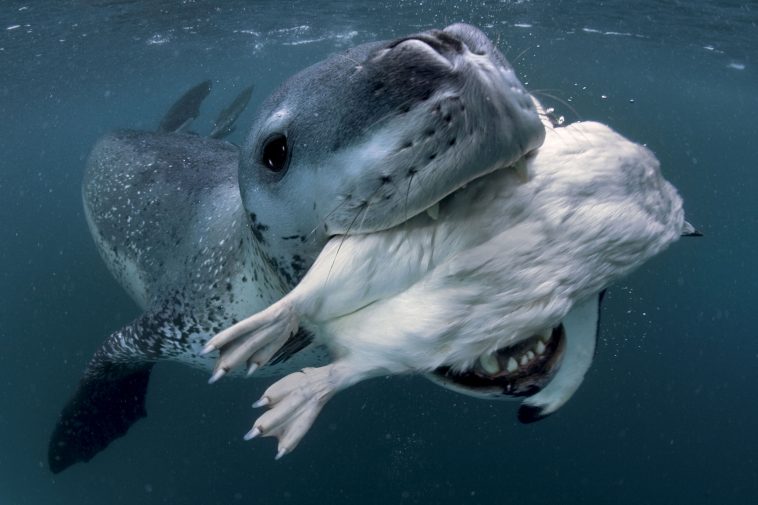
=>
[518,291,605,423]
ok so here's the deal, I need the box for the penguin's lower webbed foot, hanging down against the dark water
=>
[244,363,350,459]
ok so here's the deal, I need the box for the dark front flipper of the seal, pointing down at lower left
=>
[48,316,160,473]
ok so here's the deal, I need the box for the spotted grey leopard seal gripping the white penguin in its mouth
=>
[48,24,545,472]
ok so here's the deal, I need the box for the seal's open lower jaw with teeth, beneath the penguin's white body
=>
[430,325,566,400]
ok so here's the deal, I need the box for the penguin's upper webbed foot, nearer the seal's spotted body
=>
[202,299,300,384]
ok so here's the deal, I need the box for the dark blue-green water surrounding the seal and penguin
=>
[0,0,758,505]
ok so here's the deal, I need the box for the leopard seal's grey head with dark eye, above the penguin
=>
[239,24,545,278]
